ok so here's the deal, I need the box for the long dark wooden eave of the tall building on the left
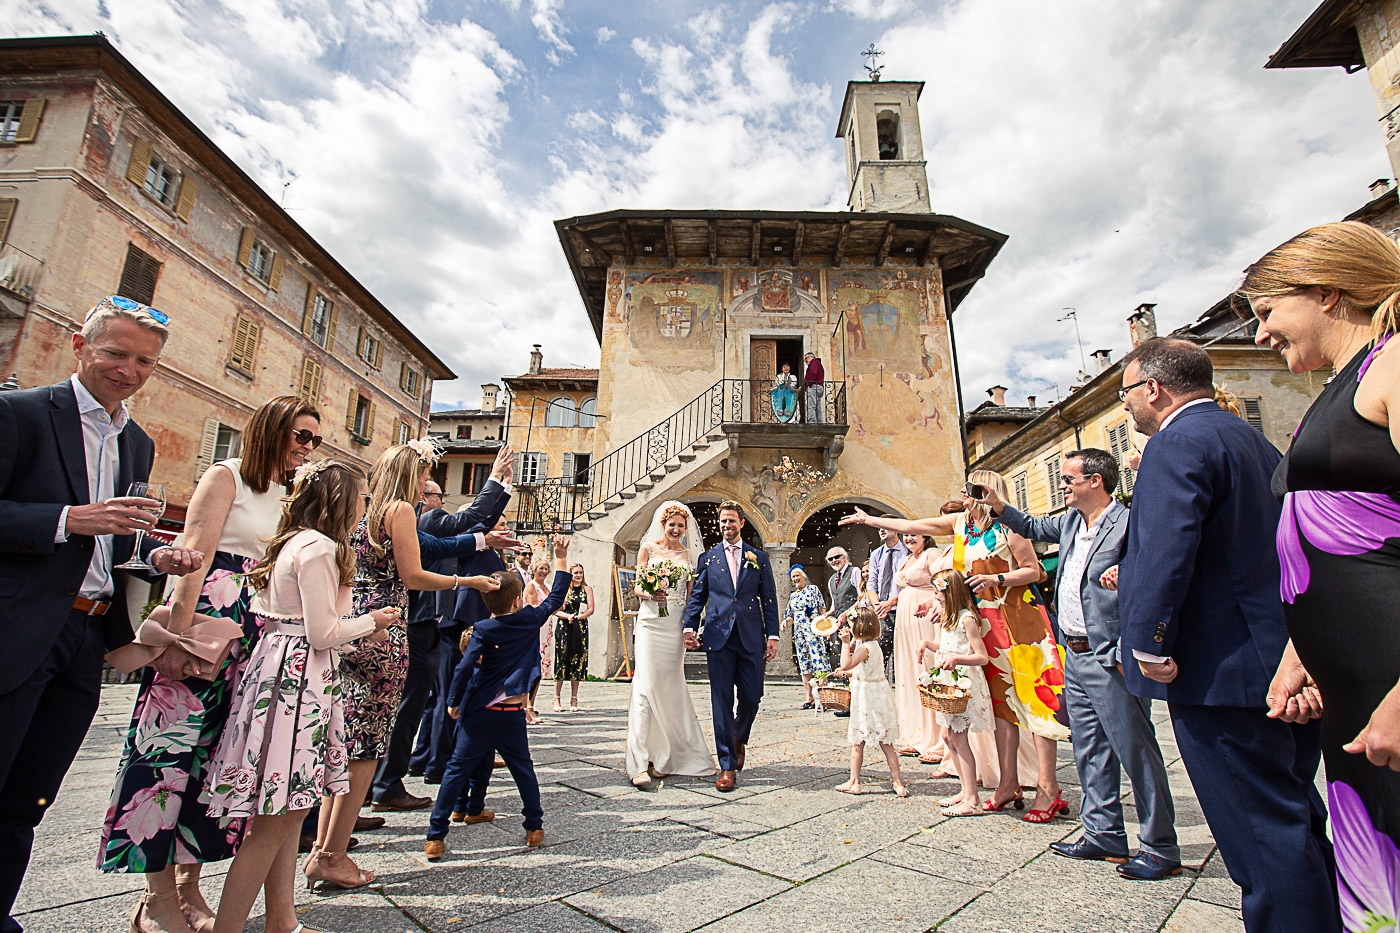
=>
[0,35,456,381]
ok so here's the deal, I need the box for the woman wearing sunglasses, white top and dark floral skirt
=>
[98,395,321,933]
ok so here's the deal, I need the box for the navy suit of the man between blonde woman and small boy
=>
[371,479,511,803]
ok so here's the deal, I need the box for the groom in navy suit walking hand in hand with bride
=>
[685,500,778,792]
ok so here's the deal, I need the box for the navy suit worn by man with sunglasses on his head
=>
[0,380,162,933]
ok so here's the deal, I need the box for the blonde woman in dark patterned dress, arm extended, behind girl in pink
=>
[305,441,498,890]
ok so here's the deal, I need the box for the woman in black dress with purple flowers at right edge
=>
[1242,223,1400,930]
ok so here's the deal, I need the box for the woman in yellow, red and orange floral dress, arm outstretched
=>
[841,471,1070,822]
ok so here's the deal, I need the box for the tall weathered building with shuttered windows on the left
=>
[0,36,454,524]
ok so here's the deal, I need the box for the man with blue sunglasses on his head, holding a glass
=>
[0,298,203,933]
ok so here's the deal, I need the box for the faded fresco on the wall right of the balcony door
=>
[830,270,928,373]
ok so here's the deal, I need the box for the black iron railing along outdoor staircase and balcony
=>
[517,380,848,534]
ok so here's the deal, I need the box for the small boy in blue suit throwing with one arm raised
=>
[423,535,573,860]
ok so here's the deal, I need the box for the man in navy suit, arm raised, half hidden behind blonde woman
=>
[371,456,511,813]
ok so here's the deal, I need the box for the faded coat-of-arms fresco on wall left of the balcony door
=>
[626,270,720,370]
